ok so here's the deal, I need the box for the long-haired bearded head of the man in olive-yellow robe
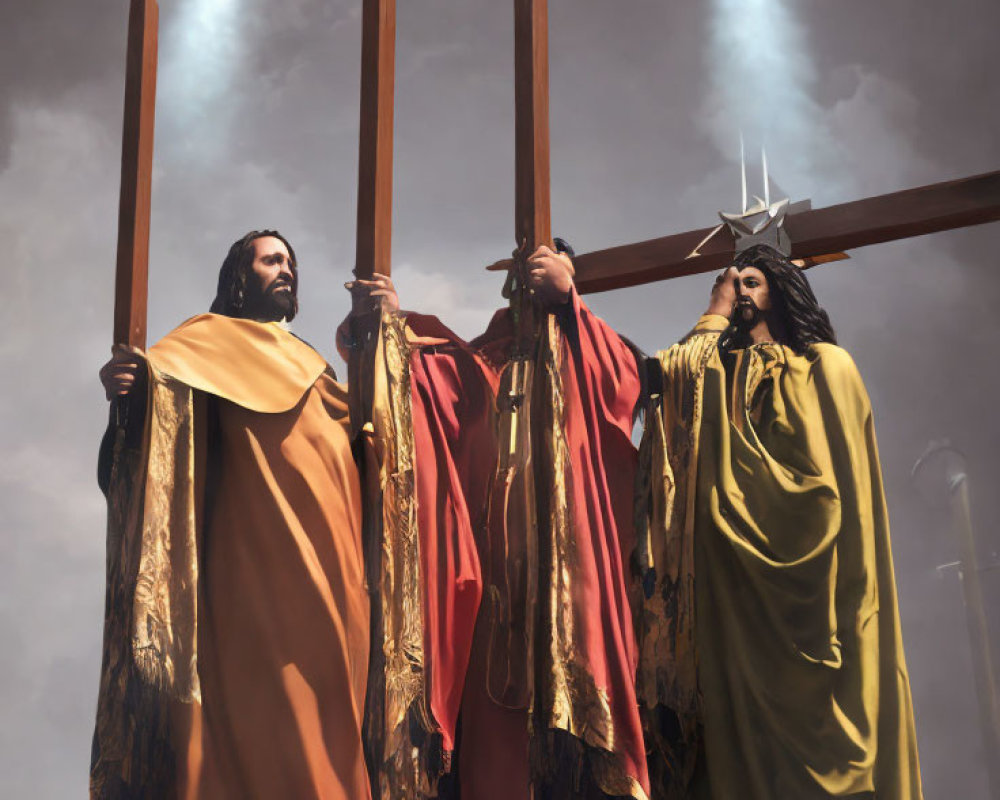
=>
[720,244,837,355]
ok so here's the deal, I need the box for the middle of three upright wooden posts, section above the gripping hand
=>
[355,0,396,278]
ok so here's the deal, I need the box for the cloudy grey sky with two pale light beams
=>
[0,0,1000,800]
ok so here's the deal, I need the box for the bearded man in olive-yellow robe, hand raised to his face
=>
[636,244,922,800]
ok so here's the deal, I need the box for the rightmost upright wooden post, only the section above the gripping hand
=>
[514,0,552,253]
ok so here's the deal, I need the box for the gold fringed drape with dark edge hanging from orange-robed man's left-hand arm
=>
[90,362,201,798]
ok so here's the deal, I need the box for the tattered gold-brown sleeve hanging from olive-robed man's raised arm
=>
[634,315,728,800]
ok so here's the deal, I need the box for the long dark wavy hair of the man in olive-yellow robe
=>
[719,244,837,355]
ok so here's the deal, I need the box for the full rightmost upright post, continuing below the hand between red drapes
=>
[487,0,552,713]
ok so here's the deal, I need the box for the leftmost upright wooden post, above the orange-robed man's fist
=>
[114,0,159,348]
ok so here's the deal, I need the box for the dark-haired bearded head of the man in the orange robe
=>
[209,230,299,322]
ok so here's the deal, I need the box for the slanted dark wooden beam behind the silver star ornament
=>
[574,171,1000,293]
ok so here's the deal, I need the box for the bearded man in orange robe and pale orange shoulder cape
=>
[91,231,386,800]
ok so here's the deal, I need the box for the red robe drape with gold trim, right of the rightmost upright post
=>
[532,293,648,798]
